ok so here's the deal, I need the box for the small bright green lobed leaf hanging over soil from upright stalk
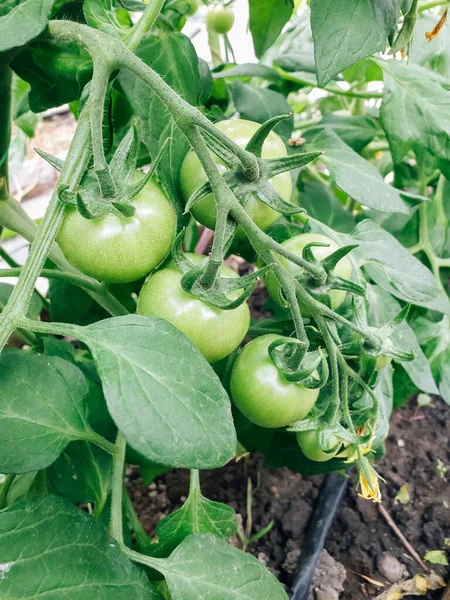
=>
[147,489,237,557]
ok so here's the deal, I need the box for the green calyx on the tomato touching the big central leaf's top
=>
[172,231,272,310]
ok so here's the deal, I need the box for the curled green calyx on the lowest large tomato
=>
[268,337,329,389]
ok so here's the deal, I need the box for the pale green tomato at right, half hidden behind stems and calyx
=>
[265,233,352,317]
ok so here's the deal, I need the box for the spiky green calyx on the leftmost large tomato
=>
[44,124,169,219]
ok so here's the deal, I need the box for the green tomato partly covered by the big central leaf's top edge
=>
[137,254,250,363]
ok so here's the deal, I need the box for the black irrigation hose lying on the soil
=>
[291,473,348,600]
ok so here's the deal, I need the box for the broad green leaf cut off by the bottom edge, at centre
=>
[158,533,287,600]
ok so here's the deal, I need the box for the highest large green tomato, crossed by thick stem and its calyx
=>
[181,119,292,236]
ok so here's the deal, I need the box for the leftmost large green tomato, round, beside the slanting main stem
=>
[58,176,176,283]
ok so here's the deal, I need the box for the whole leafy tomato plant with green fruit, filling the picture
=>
[0,0,450,600]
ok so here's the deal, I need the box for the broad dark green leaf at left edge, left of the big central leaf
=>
[0,351,95,473]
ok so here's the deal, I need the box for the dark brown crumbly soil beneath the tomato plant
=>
[129,400,450,600]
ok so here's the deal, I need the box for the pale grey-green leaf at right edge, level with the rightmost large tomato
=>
[352,219,450,314]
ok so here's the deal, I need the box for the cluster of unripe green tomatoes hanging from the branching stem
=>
[58,118,360,462]
